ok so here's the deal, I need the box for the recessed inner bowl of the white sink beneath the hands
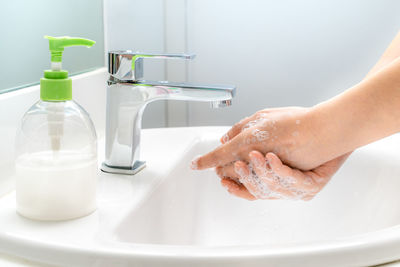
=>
[116,139,400,250]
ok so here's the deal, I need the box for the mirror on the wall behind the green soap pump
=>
[0,0,104,93]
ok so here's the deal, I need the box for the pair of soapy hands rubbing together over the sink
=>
[192,107,350,200]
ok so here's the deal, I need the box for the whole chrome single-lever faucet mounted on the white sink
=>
[101,50,236,174]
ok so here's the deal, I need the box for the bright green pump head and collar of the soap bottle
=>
[40,35,96,101]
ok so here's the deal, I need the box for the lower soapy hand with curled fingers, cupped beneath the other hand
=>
[216,151,351,200]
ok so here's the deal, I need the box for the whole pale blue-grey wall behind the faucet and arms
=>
[105,0,400,127]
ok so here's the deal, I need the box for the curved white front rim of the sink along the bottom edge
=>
[0,225,400,262]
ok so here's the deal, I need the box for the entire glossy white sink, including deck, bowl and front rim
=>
[0,127,400,267]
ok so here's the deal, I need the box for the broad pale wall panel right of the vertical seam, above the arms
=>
[187,0,400,125]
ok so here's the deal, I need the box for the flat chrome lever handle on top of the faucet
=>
[108,50,196,81]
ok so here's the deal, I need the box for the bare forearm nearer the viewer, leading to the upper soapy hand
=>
[312,58,400,160]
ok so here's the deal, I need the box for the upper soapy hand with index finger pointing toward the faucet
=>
[192,107,326,170]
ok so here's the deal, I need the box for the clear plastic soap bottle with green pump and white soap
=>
[15,36,98,221]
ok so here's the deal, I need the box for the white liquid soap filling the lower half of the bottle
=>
[16,151,97,220]
